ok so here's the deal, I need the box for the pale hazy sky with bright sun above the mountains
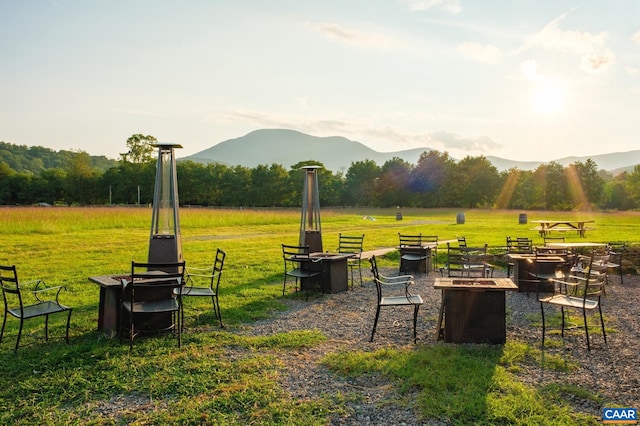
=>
[0,0,640,162]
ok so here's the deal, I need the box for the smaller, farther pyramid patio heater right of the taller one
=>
[298,166,322,253]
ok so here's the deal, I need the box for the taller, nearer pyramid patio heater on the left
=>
[149,143,182,272]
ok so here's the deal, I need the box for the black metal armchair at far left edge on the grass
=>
[0,265,72,352]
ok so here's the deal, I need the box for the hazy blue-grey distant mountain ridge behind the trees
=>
[181,129,640,173]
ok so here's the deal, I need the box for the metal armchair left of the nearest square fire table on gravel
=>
[369,256,423,343]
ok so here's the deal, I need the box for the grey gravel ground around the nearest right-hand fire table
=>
[240,264,640,425]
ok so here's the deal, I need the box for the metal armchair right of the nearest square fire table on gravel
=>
[538,255,607,351]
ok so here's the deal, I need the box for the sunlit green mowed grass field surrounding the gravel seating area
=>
[0,208,640,424]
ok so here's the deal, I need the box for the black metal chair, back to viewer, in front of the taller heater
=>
[120,261,185,349]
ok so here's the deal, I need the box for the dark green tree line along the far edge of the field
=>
[0,134,640,210]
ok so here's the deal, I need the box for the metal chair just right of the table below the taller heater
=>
[182,249,227,328]
